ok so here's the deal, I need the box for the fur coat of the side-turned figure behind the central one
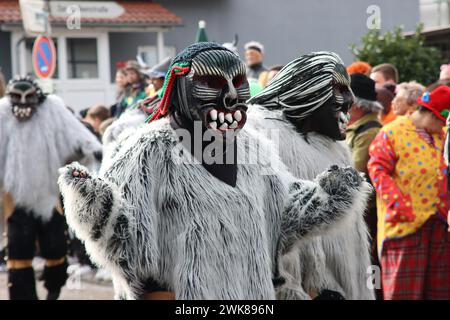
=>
[246,105,375,300]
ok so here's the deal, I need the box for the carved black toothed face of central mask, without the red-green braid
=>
[171,49,250,134]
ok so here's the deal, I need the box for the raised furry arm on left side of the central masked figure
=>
[58,163,139,297]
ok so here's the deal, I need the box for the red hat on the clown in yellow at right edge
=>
[416,86,450,122]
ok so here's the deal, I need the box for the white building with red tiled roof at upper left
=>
[0,0,181,111]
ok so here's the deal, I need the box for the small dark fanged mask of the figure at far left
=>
[6,77,45,121]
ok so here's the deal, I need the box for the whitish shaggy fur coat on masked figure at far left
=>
[0,95,102,221]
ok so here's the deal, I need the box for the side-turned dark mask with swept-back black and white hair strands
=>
[248,51,354,140]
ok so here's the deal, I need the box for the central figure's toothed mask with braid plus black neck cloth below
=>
[148,42,250,186]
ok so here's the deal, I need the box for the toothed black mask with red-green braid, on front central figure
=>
[150,43,250,134]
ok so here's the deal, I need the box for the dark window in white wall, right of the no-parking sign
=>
[67,38,98,79]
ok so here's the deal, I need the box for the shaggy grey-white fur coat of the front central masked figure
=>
[58,118,370,299]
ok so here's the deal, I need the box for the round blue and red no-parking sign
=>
[33,36,56,78]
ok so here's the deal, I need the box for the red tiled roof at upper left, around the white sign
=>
[0,0,181,28]
